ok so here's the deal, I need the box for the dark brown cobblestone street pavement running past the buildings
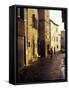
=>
[19,53,65,82]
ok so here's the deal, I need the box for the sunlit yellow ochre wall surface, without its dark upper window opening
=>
[26,9,38,65]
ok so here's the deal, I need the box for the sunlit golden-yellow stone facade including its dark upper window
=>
[25,9,38,65]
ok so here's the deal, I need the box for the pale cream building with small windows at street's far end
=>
[50,20,61,53]
